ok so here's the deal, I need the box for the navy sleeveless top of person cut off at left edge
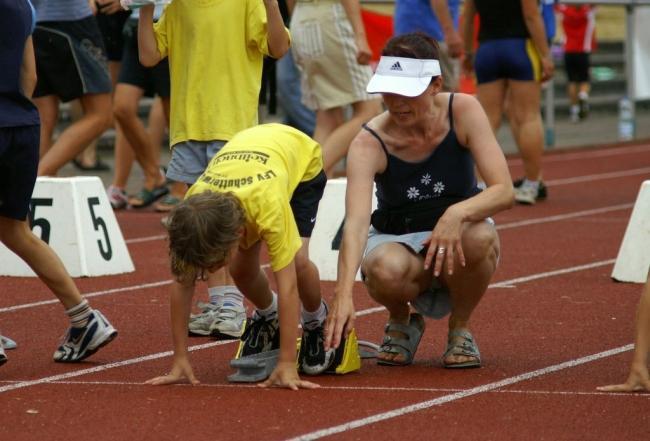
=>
[0,0,39,127]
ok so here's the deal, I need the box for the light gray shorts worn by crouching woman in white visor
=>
[364,217,494,319]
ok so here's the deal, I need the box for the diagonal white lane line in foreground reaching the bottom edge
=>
[289,344,634,441]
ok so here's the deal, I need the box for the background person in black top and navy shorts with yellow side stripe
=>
[463,0,554,205]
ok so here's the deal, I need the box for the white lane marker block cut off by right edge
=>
[612,180,650,283]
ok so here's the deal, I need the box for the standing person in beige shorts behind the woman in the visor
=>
[288,0,381,177]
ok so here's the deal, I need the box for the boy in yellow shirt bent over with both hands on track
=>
[148,124,334,389]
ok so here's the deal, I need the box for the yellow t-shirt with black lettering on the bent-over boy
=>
[186,124,323,271]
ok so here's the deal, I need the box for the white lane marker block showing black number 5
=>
[0,176,135,277]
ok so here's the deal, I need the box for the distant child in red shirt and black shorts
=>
[557,4,596,122]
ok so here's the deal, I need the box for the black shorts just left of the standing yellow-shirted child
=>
[117,20,171,98]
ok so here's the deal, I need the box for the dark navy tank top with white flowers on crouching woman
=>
[363,94,481,234]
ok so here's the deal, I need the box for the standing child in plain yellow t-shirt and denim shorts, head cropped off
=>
[138,0,290,338]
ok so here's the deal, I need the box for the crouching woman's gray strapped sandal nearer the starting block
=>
[377,313,425,366]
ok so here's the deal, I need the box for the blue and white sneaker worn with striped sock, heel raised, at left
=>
[54,309,117,363]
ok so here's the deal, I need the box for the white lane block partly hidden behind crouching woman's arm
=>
[309,178,377,280]
